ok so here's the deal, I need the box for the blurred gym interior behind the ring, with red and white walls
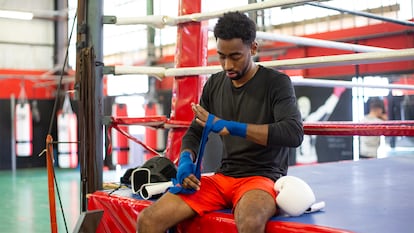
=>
[0,0,414,232]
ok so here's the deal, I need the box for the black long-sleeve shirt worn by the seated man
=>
[181,66,303,180]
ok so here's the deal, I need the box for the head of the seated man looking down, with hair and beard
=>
[214,12,257,81]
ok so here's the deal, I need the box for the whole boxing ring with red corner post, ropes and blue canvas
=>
[69,0,414,233]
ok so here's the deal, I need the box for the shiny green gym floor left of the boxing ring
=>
[0,168,119,233]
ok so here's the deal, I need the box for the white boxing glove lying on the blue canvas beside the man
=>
[274,176,315,216]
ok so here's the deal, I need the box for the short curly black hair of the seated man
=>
[214,11,256,45]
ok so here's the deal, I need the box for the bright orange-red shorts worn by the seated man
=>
[179,173,277,215]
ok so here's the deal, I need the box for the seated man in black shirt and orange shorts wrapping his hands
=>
[137,12,303,233]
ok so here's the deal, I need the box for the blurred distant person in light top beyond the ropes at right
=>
[359,97,388,159]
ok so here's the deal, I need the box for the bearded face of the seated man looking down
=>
[217,38,257,80]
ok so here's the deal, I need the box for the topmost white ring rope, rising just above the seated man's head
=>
[111,0,312,28]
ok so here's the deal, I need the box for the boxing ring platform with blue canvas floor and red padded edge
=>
[88,156,414,233]
